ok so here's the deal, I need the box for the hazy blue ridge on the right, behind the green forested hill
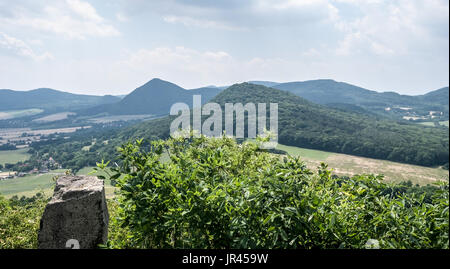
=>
[252,79,449,120]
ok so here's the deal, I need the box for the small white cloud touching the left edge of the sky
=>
[0,32,53,61]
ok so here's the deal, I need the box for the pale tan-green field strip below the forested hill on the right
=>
[277,144,449,185]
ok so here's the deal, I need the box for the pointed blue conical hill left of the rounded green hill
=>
[80,78,221,115]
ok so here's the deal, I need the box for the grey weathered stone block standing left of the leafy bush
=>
[38,176,109,249]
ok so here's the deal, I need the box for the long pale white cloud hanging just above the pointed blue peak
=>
[111,47,310,88]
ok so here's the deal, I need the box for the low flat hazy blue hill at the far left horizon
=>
[0,88,120,111]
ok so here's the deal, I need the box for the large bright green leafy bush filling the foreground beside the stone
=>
[99,137,449,249]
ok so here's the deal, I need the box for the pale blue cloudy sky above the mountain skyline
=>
[0,0,449,95]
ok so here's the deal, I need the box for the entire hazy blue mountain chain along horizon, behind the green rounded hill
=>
[0,78,449,120]
